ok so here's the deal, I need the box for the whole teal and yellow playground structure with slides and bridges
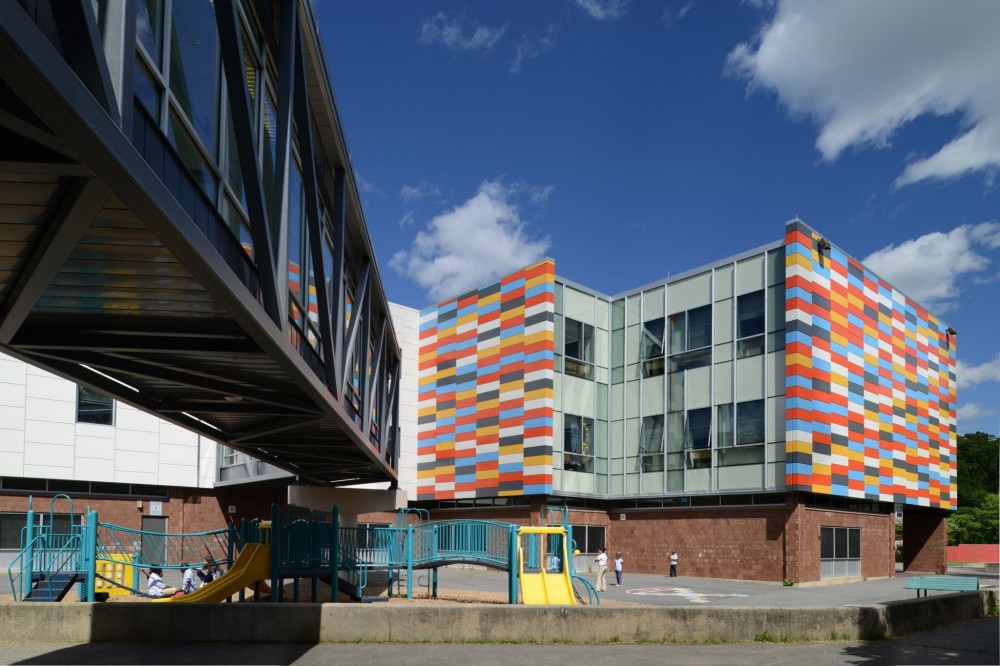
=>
[9,495,600,604]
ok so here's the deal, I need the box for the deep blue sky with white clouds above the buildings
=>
[315,0,1000,434]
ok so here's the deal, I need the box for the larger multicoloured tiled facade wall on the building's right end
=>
[785,220,957,509]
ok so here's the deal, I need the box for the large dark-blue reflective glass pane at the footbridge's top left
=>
[170,0,219,158]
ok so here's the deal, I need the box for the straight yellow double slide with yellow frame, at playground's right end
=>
[517,527,576,605]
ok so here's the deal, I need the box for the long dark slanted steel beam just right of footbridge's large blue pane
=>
[215,0,287,330]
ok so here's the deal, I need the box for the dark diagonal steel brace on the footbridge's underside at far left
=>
[0,179,111,344]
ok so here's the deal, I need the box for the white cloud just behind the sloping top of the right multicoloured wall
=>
[862,222,1000,314]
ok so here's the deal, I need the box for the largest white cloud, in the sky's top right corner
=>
[727,0,1000,186]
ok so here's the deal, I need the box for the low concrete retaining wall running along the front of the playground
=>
[0,590,997,643]
